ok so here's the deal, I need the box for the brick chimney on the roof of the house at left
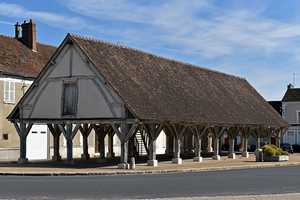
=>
[15,19,37,51]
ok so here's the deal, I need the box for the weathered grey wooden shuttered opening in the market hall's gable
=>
[62,82,78,116]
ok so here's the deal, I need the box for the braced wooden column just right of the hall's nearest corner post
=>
[144,124,163,167]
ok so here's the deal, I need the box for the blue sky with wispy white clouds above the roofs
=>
[0,0,300,100]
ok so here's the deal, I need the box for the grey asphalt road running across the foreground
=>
[0,167,300,199]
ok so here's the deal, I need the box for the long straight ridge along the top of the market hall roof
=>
[69,33,246,80]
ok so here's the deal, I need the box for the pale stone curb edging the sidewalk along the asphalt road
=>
[0,162,300,176]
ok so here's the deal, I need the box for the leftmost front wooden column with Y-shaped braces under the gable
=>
[13,122,33,163]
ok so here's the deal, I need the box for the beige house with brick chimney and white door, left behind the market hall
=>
[0,20,55,160]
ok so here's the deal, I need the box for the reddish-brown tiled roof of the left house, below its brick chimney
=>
[0,35,56,79]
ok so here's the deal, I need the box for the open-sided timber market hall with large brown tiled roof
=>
[8,34,288,168]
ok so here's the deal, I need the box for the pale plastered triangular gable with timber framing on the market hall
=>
[13,38,125,119]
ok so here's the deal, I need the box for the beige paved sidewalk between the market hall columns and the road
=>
[0,154,300,176]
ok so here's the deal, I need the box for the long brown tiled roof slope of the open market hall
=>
[69,35,287,127]
